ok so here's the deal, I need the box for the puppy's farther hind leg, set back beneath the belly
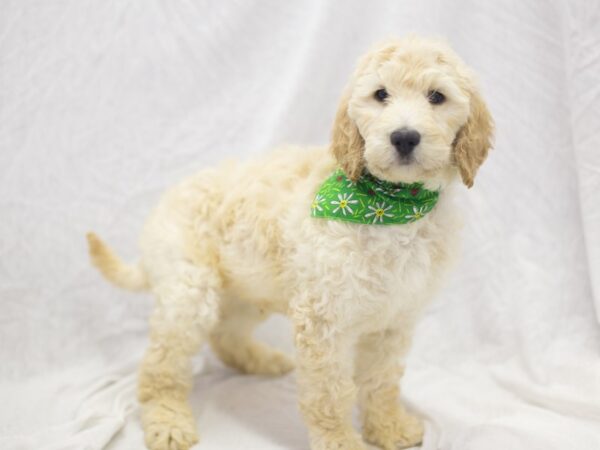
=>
[210,300,294,375]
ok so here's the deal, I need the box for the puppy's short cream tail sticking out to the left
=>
[86,233,148,291]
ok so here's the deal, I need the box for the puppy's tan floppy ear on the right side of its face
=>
[453,89,494,187]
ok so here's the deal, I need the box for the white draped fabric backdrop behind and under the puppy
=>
[0,0,600,450]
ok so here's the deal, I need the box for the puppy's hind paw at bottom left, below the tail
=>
[142,402,198,450]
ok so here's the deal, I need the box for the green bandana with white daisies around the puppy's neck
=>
[312,169,439,225]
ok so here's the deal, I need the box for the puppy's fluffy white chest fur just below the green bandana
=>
[300,215,451,332]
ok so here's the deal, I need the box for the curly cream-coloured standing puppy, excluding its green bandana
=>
[88,37,493,450]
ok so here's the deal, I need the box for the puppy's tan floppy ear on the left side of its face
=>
[331,87,365,181]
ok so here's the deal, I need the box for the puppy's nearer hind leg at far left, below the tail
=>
[138,261,221,450]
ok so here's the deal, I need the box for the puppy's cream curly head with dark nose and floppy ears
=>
[331,37,494,187]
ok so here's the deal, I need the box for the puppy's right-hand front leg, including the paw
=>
[356,329,423,450]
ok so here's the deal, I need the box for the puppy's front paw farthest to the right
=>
[364,412,423,450]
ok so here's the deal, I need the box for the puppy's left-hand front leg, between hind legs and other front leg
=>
[295,315,365,450]
